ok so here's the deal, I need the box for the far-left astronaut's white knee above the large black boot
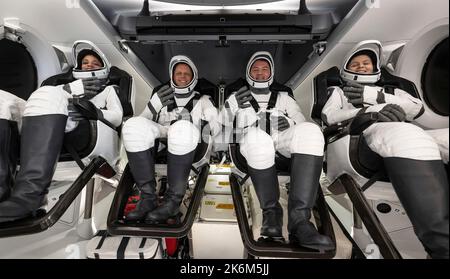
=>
[24,86,71,116]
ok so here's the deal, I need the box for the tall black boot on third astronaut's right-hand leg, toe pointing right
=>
[288,154,335,251]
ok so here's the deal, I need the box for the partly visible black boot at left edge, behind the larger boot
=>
[0,119,17,202]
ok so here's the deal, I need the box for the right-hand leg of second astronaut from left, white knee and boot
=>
[145,120,200,224]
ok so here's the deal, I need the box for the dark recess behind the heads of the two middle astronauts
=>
[129,41,313,84]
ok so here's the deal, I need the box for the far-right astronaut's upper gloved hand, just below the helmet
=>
[342,81,385,107]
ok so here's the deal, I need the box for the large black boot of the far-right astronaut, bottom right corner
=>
[384,158,449,259]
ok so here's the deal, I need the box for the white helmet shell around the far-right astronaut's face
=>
[340,40,382,83]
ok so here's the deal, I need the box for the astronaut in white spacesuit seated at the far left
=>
[0,41,123,222]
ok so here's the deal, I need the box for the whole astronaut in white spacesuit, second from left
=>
[122,55,220,224]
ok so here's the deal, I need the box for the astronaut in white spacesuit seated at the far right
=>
[322,41,449,258]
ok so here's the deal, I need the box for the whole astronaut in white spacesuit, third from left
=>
[219,51,335,253]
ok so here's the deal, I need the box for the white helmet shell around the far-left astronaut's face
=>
[72,40,111,79]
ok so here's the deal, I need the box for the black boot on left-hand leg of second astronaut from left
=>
[126,148,157,222]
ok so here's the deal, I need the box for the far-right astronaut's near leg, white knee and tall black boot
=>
[364,123,449,259]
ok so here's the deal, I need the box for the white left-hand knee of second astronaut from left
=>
[122,116,159,152]
